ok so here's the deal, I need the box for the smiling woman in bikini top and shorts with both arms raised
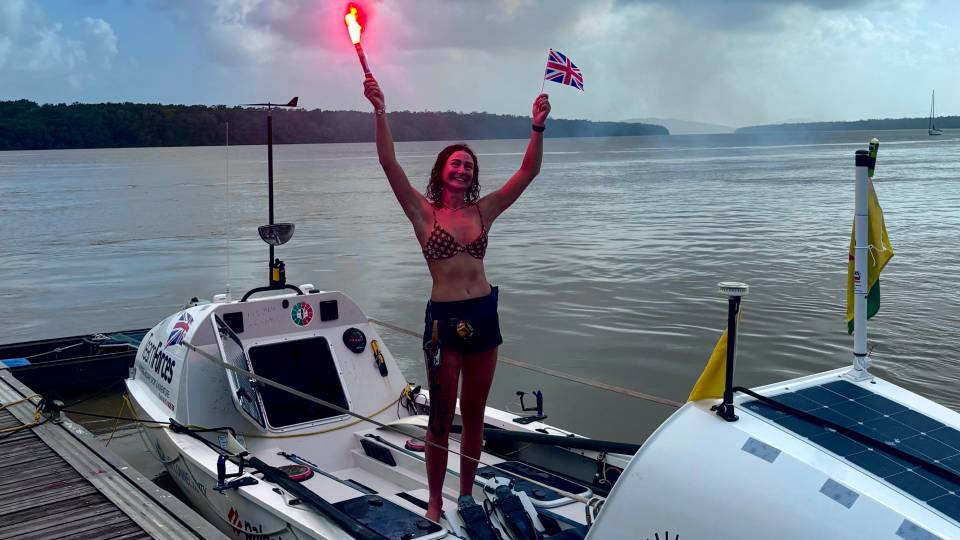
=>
[364,78,550,521]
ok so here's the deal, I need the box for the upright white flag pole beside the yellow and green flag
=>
[844,148,879,381]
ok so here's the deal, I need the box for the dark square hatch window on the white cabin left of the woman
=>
[249,337,350,427]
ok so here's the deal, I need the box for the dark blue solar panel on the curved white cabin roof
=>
[743,381,960,522]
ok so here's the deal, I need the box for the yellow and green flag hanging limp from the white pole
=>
[847,179,893,334]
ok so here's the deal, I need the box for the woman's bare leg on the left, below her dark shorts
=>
[425,349,462,522]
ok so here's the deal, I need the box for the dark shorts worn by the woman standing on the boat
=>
[423,287,503,354]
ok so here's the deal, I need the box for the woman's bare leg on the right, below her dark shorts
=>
[460,347,497,495]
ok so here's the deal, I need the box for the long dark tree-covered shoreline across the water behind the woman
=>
[0,99,668,150]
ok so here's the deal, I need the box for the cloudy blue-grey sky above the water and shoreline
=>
[0,0,960,126]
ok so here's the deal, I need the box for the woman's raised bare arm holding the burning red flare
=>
[363,78,430,225]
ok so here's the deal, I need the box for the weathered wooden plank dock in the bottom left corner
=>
[0,370,227,540]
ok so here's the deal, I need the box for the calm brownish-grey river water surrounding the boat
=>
[0,131,960,459]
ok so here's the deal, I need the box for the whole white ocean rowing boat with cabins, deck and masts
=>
[126,127,960,540]
